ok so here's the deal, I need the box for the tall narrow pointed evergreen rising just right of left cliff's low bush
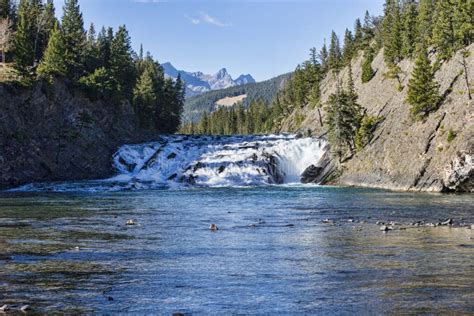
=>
[110,26,136,99]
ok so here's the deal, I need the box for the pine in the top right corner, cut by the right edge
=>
[454,0,474,49]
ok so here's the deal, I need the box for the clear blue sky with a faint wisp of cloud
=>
[55,0,383,81]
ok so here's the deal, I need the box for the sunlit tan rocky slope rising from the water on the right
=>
[281,45,474,192]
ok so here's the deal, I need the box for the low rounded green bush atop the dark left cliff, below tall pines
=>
[79,67,117,98]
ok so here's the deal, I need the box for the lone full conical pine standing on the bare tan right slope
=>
[407,46,439,118]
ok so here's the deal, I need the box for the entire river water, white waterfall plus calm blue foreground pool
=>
[0,136,474,314]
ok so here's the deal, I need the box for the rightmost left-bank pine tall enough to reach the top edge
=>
[61,0,86,79]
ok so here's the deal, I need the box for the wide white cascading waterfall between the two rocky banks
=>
[13,135,328,192]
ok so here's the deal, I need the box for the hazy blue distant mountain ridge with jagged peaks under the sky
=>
[161,62,255,97]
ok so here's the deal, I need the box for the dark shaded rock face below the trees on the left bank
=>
[0,82,157,188]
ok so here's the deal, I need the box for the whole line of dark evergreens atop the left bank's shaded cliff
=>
[0,0,184,133]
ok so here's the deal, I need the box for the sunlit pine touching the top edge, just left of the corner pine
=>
[433,0,456,60]
